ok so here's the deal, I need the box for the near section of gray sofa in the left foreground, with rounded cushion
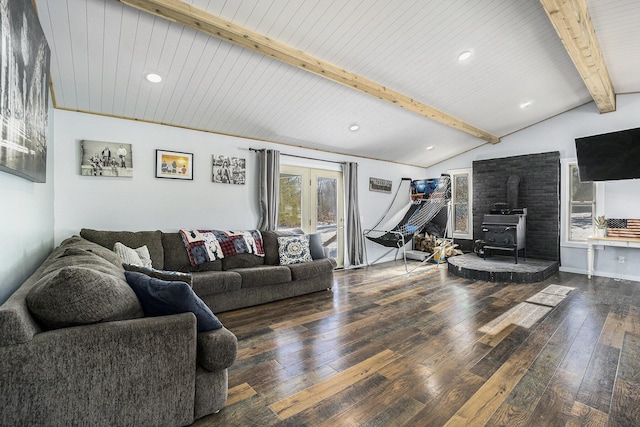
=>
[0,236,237,426]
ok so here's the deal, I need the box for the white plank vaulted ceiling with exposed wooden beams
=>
[35,0,640,167]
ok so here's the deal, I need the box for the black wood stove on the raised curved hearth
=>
[482,208,527,264]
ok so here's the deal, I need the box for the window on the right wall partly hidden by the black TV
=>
[567,163,596,242]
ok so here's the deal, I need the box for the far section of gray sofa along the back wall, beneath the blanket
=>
[80,229,336,313]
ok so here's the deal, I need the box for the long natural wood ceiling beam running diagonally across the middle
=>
[119,0,500,144]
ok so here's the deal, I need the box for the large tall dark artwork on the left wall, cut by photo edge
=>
[0,0,51,182]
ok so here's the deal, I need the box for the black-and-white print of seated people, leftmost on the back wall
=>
[80,139,133,178]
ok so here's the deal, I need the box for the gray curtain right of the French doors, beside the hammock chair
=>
[342,162,364,266]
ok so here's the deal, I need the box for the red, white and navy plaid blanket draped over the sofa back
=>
[180,229,264,265]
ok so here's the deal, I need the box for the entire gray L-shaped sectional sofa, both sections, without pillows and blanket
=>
[0,229,335,426]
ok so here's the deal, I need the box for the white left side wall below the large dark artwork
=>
[0,103,54,304]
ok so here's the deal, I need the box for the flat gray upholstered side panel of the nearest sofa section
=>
[0,313,197,426]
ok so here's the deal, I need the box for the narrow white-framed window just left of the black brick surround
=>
[449,169,473,239]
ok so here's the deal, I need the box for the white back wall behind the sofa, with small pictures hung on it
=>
[55,110,424,259]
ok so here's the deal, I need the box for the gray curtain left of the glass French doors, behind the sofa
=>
[258,150,280,230]
